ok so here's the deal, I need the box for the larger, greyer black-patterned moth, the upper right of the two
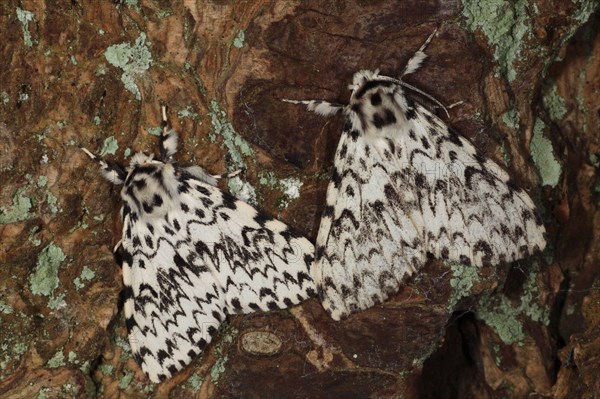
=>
[284,32,546,320]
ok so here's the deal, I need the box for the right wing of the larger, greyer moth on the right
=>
[397,104,546,266]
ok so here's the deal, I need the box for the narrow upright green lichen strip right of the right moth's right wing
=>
[530,119,562,187]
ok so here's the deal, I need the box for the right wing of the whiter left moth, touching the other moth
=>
[181,179,315,313]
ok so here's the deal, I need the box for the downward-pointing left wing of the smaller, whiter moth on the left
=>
[122,208,225,382]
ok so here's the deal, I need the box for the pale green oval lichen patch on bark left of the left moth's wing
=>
[29,243,66,297]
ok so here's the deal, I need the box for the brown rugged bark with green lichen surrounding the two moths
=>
[0,0,600,398]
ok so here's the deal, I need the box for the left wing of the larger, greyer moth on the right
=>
[313,131,424,320]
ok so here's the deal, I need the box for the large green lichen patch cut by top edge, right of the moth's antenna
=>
[463,0,530,82]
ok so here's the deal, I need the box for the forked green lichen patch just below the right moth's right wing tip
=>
[477,264,550,345]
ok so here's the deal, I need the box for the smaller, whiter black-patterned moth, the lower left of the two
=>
[83,106,315,382]
